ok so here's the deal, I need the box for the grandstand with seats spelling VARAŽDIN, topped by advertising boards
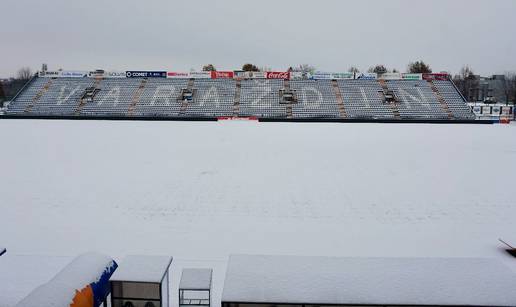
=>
[5,70,475,122]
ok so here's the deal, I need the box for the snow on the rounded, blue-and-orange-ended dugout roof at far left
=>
[16,253,113,307]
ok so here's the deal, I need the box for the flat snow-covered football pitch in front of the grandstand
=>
[0,120,516,307]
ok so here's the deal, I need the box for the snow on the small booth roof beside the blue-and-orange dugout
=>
[111,255,173,283]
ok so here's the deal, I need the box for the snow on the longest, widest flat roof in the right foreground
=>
[222,255,516,306]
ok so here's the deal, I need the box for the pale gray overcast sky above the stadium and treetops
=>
[0,0,516,77]
